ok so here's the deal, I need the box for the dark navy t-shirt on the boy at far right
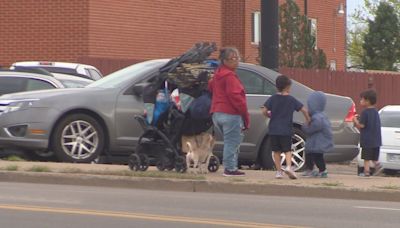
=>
[360,108,382,148]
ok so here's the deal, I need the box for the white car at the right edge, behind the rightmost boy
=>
[357,105,400,174]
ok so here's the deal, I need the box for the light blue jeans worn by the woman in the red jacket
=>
[213,112,243,171]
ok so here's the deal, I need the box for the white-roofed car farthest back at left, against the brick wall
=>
[11,61,103,81]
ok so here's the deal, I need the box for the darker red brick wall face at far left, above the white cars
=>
[0,0,88,66]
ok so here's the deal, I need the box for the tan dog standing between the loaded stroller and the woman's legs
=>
[182,133,215,173]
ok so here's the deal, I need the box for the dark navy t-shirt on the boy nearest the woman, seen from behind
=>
[264,94,303,136]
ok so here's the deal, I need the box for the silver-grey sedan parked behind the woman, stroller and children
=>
[0,59,359,169]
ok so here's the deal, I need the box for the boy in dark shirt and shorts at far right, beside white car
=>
[353,90,383,177]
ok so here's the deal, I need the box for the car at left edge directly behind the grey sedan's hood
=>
[0,68,93,95]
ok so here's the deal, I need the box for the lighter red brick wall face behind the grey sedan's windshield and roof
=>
[89,0,222,60]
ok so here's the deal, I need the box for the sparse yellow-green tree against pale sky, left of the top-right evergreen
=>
[347,0,400,69]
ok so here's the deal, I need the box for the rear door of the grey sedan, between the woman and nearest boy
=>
[215,68,276,158]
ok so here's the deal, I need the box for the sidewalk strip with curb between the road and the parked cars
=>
[0,161,400,201]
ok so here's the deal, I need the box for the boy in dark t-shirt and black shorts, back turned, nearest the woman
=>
[262,75,310,179]
